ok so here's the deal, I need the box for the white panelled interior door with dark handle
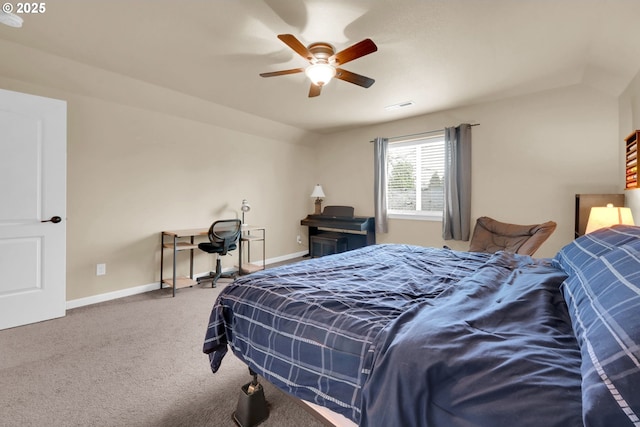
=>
[0,89,67,329]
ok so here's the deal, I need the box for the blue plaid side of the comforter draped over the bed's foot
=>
[204,245,490,420]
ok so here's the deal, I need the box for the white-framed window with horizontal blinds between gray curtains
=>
[387,133,444,220]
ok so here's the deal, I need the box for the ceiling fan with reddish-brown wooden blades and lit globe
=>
[260,34,378,98]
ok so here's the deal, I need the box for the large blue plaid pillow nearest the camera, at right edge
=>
[562,239,640,426]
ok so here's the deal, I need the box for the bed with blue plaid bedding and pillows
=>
[203,226,640,427]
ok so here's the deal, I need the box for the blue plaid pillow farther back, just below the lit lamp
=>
[553,225,640,275]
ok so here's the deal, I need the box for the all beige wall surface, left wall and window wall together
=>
[0,36,640,300]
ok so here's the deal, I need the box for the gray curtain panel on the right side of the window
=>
[442,123,471,240]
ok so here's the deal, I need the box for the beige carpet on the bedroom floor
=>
[0,280,322,427]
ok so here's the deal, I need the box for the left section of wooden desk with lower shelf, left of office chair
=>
[160,228,209,297]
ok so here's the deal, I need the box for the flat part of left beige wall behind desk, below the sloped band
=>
[67,96,312,299]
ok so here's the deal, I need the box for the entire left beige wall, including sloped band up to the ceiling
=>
[0,43,317,301]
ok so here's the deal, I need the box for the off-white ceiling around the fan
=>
[0,0,640,132]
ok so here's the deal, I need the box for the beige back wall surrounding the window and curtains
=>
[318,86,621,256]
